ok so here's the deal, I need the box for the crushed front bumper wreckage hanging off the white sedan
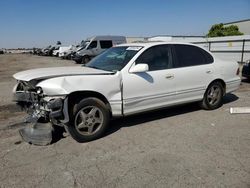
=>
[13,87,69,145]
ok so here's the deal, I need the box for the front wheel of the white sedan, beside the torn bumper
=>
[67,97,110,142]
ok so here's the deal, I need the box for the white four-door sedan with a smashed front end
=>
[13,42,241,142]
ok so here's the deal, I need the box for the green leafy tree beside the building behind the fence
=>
[207,23,243,37]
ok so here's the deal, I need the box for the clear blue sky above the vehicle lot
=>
[0,0,250,48]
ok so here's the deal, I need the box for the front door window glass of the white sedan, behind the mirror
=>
[135,45,172,71]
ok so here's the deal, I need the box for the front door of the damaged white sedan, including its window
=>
[123,45,175,115]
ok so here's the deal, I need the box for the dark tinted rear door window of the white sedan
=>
[174,44,213,67]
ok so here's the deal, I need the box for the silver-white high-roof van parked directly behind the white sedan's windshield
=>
[72,36,126,64]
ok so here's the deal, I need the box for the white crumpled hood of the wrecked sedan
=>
[13,66,112,81]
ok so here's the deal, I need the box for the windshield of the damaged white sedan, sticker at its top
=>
[85,46,142,72]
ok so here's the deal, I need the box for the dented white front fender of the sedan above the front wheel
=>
[37,72,122,101]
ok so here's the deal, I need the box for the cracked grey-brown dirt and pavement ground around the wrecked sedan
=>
[0,54,250,188]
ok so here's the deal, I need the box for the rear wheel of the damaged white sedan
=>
[200,82,223,110]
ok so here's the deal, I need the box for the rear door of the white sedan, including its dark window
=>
[172,44,214,103]
